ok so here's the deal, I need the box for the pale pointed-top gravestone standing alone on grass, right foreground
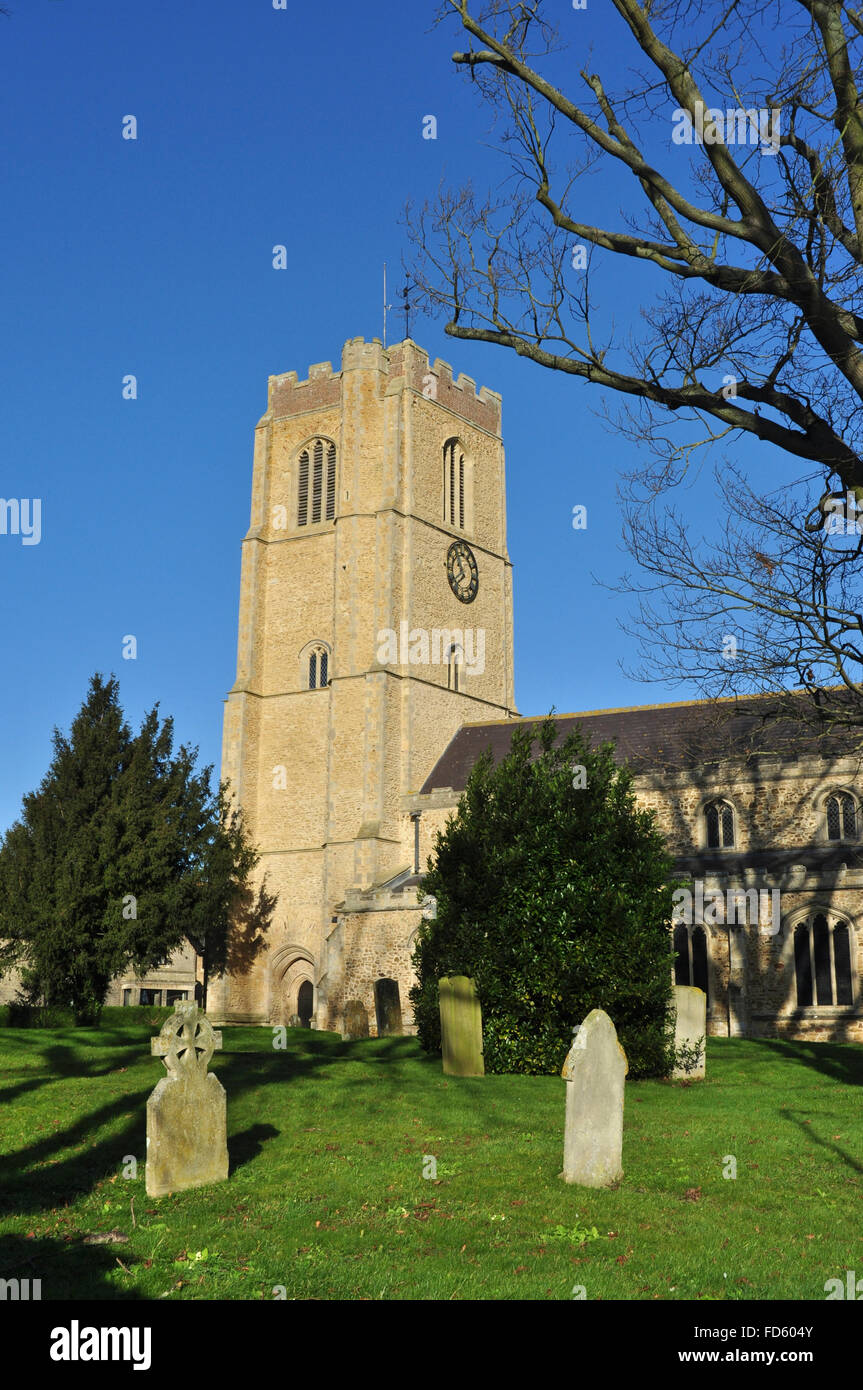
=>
[560,1009,628,1187]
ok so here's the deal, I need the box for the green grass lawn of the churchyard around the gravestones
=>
[0,1015,863,1300]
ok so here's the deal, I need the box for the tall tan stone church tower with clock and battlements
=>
[210,338,516,1031]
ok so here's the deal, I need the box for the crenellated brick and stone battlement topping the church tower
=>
[267,338,502,435]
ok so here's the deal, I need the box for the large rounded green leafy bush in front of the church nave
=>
[410,719,674,1077]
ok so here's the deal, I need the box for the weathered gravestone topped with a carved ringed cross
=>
[146,1001,228,1197]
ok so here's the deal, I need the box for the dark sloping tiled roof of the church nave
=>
[420,696,853,795]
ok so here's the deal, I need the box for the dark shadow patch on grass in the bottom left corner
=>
[0,1236,140,1316]
